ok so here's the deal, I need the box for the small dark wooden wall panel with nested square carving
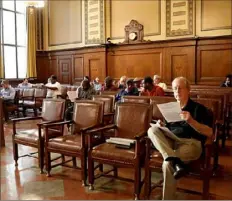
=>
[58,57,72,84]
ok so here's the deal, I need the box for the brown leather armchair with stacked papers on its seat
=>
[88,103,151,199]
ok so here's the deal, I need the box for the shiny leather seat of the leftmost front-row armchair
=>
[15,129,61,143]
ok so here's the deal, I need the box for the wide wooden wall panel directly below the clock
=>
[107,47,163,79]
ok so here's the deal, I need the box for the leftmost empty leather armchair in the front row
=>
[12,99,65,173]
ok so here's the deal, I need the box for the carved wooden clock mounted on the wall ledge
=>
[123,20,150,44]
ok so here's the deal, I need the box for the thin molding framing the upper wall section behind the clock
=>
[110,0,161,40]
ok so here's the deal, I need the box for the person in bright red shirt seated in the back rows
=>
[140,77,164,96]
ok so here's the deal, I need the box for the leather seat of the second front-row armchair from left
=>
[48,134,102,151]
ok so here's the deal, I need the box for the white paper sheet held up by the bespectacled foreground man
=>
[157,102,183,123]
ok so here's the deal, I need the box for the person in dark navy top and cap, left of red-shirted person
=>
[115,79,139,101]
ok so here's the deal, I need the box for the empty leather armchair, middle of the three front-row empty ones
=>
[44,100,104,186]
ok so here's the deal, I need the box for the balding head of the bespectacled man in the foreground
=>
[172,77,190,102]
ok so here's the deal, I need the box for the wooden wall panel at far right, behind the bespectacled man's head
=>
[197,42,232,85]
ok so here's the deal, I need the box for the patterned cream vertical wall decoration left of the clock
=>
[85,0,104,44]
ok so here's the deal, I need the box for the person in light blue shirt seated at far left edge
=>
[0,80,16,121]
